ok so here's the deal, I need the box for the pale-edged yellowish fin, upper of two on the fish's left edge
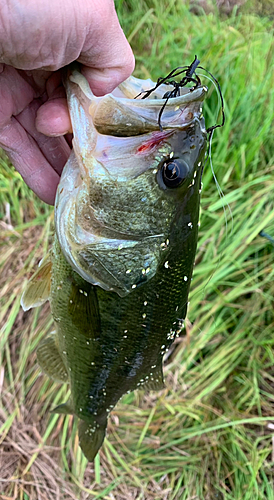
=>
[21,255,52,311]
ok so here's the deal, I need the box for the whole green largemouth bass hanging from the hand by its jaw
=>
[21,65,207,461]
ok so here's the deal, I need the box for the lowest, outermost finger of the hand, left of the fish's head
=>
[0,117,60,205]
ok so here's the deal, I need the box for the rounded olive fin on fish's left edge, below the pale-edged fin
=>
[36,332,68,383]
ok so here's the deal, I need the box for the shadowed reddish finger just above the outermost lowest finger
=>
[16,99,70,175]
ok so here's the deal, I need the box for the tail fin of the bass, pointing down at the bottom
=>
[78,419,107,462]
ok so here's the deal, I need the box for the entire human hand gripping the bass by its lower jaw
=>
[0,0,134,204]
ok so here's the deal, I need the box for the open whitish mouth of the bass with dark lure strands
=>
[65,66,207,137]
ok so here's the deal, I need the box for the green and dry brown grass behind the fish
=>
[0,0,274,500]
